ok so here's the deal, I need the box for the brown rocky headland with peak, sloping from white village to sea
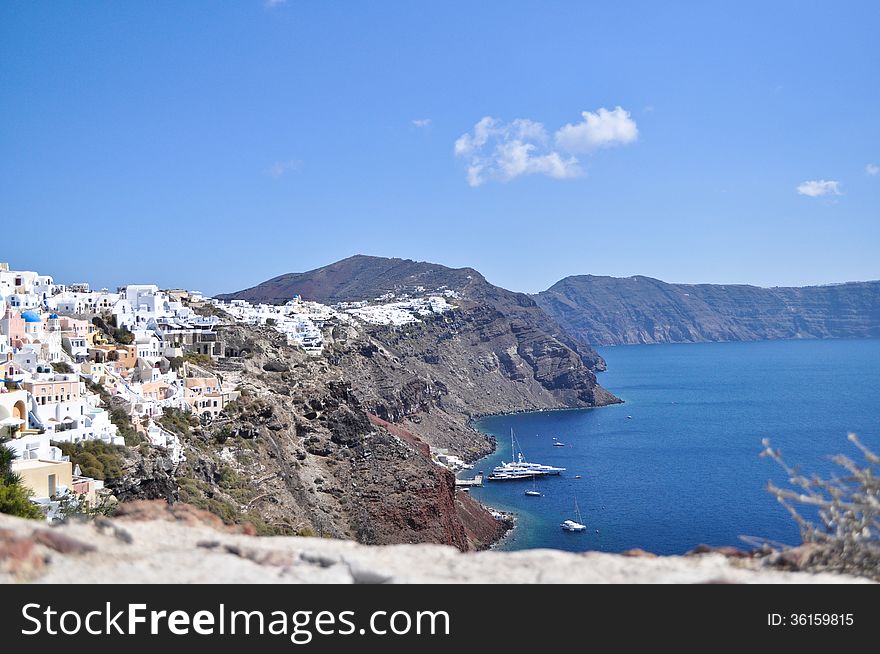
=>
[155,257,618,550]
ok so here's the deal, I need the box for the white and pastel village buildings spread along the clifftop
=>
[0,263,455,521]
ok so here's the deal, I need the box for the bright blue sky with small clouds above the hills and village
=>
[0,0,880,292]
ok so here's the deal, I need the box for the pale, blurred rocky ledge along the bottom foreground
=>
[0,502,866,584]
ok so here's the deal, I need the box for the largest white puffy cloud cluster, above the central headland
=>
[454,107,638,186]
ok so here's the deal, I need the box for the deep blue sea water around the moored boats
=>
[472,340,880,554]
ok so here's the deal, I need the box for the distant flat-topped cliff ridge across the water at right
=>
[534,275,880,345]
